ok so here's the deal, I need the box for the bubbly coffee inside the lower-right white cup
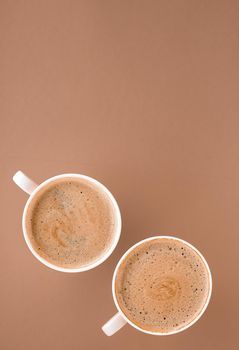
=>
[115,238,210,333]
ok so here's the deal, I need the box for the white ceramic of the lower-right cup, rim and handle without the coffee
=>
[102,236,212,336]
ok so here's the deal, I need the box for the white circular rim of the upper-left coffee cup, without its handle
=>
[22,173,122,273]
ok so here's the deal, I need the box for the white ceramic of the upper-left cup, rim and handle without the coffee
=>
[13,171,121,272]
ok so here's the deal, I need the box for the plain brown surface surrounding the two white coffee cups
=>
[0,0,239,350]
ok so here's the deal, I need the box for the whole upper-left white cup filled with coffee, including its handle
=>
[14,172,121,272]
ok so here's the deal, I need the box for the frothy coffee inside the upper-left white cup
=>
[27,178,114,268]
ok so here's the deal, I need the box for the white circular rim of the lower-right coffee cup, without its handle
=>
[112,236,212,336]
